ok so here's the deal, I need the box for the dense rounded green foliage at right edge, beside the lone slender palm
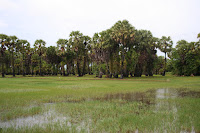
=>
[171,40,200,76]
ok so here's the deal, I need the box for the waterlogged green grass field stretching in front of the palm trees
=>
[0,74,200,133]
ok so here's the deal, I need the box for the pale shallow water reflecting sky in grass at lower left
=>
[0,103,91,132]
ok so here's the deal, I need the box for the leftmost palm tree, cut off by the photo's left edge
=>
[0,34,8,77]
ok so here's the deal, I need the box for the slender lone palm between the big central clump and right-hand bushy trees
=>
[159,36,173,76]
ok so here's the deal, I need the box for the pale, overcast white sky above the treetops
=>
[0,0,200,55]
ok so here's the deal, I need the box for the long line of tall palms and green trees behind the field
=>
[0,20,200,78]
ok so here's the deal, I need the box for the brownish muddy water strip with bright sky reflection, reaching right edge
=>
[94,88,200,104]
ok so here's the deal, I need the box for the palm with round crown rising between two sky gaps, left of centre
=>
[34,39,46,76]
